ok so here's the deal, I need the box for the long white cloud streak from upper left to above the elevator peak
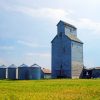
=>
[0,2,72,20]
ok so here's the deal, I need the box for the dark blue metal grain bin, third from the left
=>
[18,64,29,80]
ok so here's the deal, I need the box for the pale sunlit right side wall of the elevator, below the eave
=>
[71,41,83,78]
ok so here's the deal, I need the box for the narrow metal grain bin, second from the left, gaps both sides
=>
[8,64,17,79]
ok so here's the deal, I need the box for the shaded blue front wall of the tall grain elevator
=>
[52,36,71,78]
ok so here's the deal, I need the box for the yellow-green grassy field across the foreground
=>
[0,79,100,100]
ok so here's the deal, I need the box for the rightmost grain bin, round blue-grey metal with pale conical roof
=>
[29,64,41,79]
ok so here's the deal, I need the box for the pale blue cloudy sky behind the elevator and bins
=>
[0,0,100,68]
